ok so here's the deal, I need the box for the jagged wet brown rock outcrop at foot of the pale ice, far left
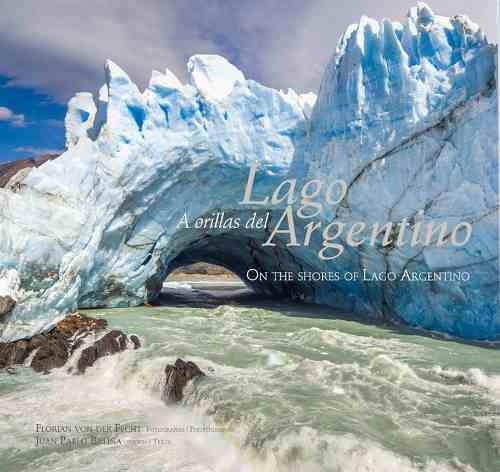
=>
[0,313,141,373]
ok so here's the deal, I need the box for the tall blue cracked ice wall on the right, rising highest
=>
[294,3,500,338]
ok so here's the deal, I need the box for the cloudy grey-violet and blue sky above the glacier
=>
[0,0,497,162]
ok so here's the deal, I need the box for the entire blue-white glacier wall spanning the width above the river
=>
[0,3,500,341]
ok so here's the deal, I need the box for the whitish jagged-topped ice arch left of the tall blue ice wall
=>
[0,56,324,339]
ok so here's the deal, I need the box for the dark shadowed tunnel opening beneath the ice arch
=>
[149,231,322,310]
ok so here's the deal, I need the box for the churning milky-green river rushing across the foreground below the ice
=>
[0,305,500,472]
